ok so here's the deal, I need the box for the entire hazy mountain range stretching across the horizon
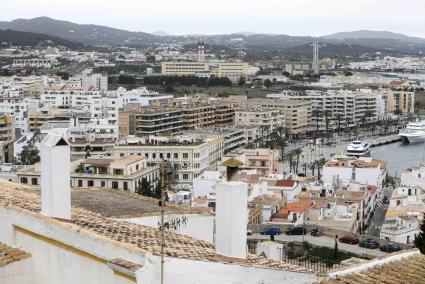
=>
[0,17,425,57]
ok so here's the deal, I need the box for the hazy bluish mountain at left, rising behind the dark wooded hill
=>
[0,17,158,44]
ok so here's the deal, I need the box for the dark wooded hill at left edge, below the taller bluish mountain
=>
[0,30,82,49]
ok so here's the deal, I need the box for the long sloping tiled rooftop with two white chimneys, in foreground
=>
[0,181,308,272]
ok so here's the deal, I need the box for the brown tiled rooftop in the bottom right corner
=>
[321,253,425,284]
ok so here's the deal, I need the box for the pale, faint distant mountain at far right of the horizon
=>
[321,30,425,43]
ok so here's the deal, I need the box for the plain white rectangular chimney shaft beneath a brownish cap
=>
[215,182,248,258]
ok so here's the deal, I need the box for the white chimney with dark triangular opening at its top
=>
[40,134,71,219]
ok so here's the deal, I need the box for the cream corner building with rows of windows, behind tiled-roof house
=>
[114,136,224,189]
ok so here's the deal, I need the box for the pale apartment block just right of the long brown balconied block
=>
[235,107,285,131]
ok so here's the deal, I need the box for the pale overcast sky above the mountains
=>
[0,0,425,37]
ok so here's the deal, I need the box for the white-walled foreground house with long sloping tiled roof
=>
[0,170,318,284]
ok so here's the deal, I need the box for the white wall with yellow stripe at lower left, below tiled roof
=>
[0,206,146,284]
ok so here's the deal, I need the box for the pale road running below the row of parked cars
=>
[248,234,387,257]
